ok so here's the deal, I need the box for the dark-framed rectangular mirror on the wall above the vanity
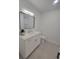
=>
[19,11,35,29]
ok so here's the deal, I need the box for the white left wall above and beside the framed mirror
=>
[19,0,40,30]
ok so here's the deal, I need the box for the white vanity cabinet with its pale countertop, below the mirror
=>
[19,32,41,58]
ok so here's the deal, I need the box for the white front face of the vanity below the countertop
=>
[25,36,40,57]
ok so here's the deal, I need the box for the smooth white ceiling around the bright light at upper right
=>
[24,0,60,12]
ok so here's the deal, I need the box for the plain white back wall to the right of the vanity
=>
[40,9,60,45]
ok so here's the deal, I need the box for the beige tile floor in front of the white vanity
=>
[20,41,59,59]
